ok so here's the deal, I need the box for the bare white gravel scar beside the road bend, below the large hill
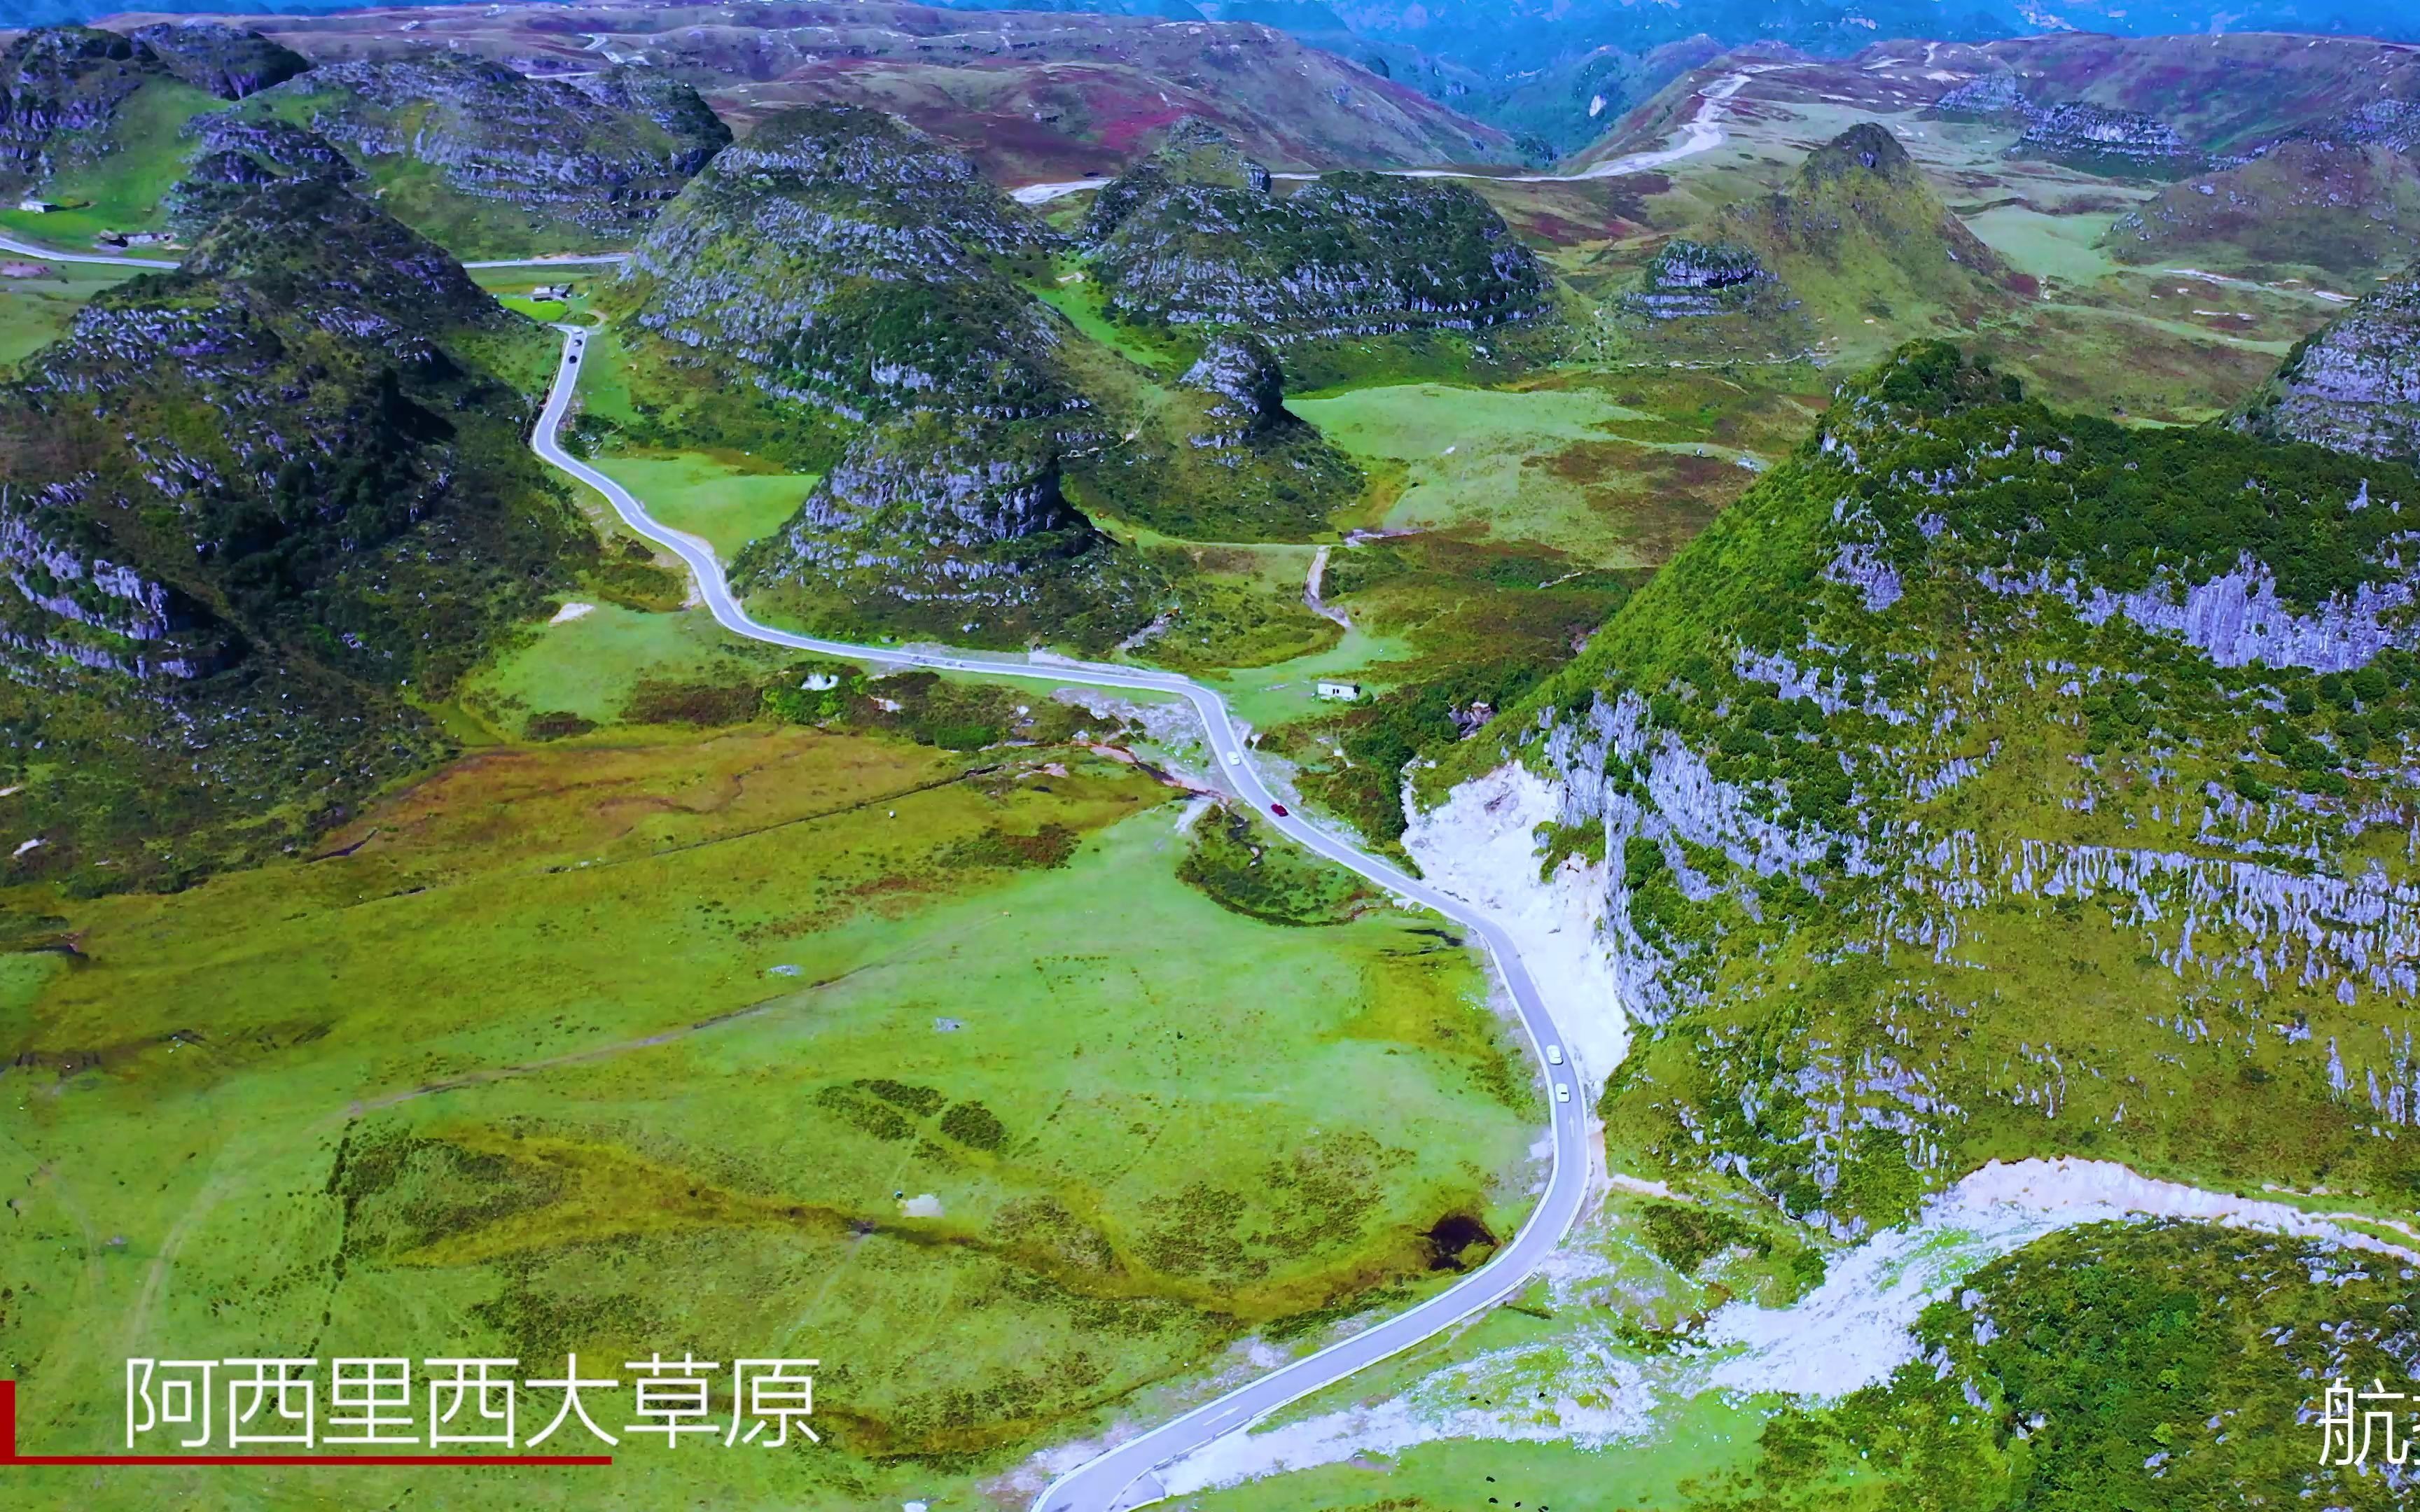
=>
[1403,764,1631,1098]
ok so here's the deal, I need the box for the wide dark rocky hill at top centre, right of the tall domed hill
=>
[1087,126,1546,341]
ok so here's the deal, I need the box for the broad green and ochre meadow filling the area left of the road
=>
[0,728,1537,1507]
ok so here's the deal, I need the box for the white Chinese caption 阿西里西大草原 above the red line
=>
[126,1350,823,1449]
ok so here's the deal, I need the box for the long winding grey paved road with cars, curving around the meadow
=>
[530,327,1590,1512]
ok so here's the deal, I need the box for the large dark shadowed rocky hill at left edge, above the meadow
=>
[0,179,595,881]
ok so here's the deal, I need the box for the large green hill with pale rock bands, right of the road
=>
[1501,344,2420,1234]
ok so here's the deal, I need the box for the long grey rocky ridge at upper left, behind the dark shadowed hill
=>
[254,51,731,239]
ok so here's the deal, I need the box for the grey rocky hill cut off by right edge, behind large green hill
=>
[2234,266,2420,460]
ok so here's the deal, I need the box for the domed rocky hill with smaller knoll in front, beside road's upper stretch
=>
[624,106,1150,643]
